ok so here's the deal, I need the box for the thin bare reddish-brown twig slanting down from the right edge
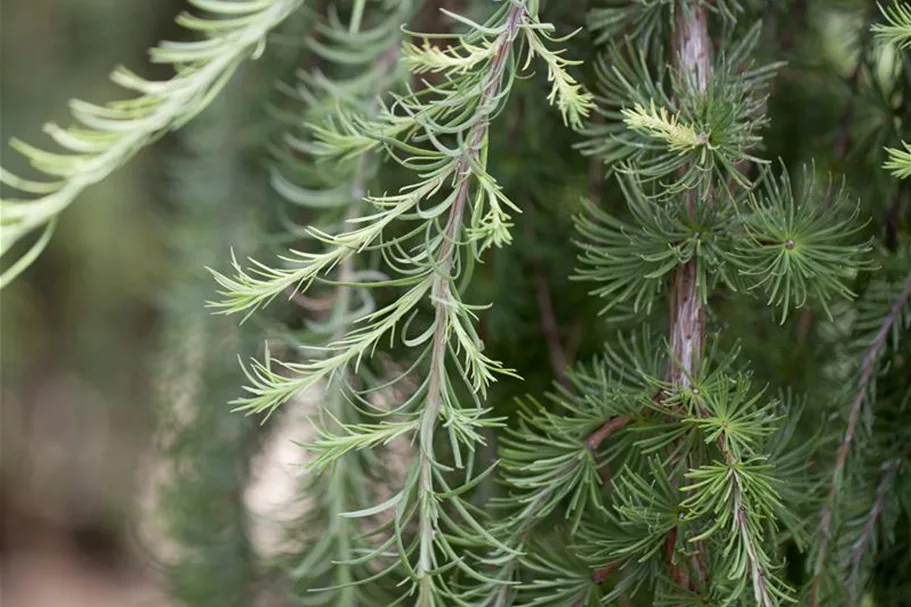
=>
[810,276,911,607]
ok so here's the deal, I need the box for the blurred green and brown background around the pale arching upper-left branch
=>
[0,0,175,607]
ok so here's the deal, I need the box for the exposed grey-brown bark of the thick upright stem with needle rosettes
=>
[669,2,712,387]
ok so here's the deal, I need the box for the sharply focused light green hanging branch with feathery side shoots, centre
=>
[212,0,591,607]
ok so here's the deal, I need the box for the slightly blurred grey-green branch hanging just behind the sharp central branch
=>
[272,2,414,607]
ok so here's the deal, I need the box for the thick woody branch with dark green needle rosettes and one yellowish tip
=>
[577,2,816,607]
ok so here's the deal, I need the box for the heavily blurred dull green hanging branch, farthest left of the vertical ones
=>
[156,70,262,607]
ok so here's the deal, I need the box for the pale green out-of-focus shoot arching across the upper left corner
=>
[0,0,303,288]
